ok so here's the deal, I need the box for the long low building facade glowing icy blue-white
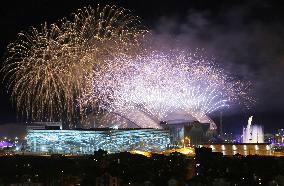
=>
[27,129,170,154]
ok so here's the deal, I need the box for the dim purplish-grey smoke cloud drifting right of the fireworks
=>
[150,3,284,113]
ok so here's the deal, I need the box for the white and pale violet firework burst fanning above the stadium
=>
[83,50,253,129]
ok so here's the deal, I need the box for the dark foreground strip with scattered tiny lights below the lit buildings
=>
[0,149,284,186]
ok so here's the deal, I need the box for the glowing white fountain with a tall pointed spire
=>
[243,116,264,143]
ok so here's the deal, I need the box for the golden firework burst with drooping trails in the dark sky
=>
[1,6,146,127]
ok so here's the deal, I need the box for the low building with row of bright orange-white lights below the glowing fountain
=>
[200,143,273,156]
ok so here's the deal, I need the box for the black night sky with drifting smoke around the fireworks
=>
[0,0,284,133]
